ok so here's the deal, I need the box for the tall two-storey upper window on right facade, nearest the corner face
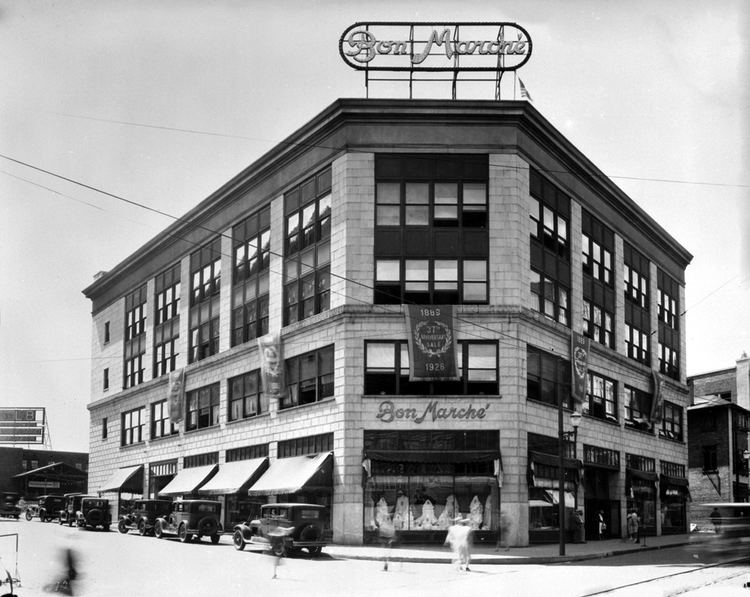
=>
[529,168,570,326]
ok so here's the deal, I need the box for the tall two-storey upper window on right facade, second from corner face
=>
[581,209,615,348]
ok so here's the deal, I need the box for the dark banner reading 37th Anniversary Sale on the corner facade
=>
[406,305,458,381]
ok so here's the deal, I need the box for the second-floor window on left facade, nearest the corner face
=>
[280,345,333,408]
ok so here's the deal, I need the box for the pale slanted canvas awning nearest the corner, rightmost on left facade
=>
[247,452,333,495]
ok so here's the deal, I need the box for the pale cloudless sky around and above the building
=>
[0,0,750,451]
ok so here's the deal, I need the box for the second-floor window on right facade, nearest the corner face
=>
[526,346,573,409]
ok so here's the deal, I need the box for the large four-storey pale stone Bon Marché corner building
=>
[84,99,692,545]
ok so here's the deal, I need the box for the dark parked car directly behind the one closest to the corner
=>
[154,500,221,544]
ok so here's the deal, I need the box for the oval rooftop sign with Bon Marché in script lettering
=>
[339,22,532,72]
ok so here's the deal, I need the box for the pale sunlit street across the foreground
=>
[0,520,750,597]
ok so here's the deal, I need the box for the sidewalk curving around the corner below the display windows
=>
[323,534,705,565]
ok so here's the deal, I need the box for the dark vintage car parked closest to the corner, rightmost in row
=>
[232,503,326,556]
